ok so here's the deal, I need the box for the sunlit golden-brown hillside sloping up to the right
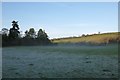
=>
[51,32,120,44]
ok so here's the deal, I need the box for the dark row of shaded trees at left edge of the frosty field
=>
[1,21,51,47]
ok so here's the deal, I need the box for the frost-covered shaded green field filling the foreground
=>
[2,45,118,78]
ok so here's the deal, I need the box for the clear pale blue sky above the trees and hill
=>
[2,2,118,38]
